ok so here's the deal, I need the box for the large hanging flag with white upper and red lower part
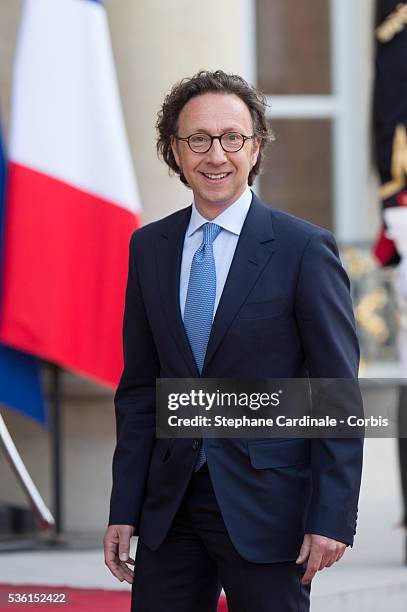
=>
[0,0,140,385]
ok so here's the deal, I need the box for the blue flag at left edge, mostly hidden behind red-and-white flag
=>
[0,111,48,425]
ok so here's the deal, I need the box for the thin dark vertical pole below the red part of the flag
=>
[51,363,64,539]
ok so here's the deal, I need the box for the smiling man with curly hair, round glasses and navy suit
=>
[105,71,362,612]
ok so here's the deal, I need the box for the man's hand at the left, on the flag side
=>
[103,525,134,584]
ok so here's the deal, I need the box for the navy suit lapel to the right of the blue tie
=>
[203,194,275,375]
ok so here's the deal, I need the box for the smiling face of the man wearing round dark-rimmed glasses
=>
[172,93,260,219]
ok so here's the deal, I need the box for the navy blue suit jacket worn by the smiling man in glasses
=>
[109,195,362,563]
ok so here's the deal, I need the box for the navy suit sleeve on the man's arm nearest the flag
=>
[109,232,160,532]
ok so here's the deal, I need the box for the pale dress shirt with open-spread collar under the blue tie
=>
[179,187,252,318]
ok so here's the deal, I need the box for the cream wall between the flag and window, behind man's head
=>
[105,0,255,222]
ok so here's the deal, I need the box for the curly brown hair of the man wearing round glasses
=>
[156,70,274,185]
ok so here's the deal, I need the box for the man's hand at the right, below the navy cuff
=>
[296,533,346,584]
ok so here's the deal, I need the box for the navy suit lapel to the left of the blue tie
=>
[156,206,199,378]
